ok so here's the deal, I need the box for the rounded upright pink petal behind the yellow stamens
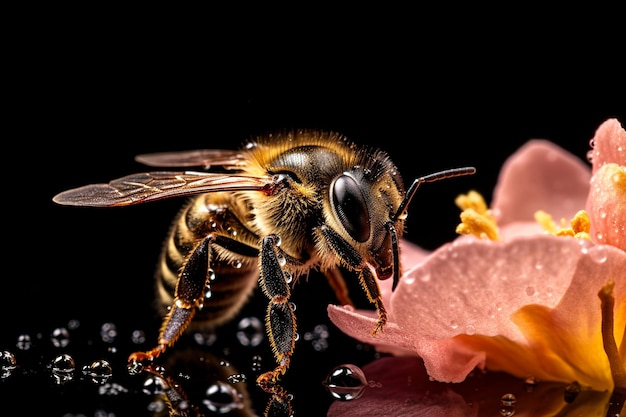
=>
[491,140,591,226]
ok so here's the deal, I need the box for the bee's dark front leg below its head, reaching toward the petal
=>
[320,226,387,335]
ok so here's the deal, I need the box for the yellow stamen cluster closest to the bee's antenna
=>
[454,191,500,240]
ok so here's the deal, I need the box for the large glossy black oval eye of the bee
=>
[330,174,370,242]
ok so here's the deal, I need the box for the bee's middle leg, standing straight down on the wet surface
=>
[257,235,296,397]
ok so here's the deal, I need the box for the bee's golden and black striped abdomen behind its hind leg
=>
[156,193,259,326]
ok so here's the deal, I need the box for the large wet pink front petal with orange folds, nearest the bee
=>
[329,235,626,385]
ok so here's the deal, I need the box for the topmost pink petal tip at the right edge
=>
[591,119,626,174]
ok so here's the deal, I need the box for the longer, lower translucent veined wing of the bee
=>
[53,171,273,207]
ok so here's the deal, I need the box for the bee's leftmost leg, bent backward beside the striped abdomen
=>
[128,235,216,363]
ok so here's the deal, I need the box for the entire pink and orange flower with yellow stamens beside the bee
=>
[329,119,626,415]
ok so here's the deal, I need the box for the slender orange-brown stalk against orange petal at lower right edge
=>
[598,281,626,392]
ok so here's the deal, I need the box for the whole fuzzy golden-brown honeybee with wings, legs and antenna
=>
[54,131,474,394]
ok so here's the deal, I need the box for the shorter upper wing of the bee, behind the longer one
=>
[135,149,245,169]
